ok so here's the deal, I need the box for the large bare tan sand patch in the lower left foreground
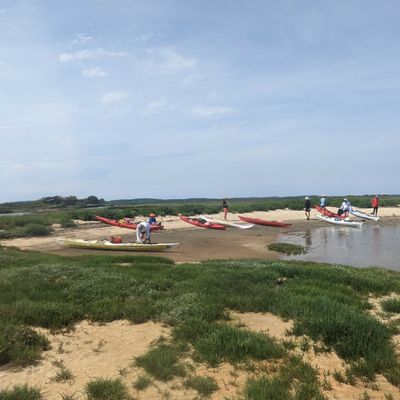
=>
[0,321,169,400]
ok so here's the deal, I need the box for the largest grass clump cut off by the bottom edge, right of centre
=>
[244,357,325,400]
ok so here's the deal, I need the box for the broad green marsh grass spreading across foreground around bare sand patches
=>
[0,247,400,399]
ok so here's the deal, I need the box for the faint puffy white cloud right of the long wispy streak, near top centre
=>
[147,48,197,72]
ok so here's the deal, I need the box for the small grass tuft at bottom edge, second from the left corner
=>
[85,378,132,400]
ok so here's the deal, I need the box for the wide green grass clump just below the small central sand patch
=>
[175,318,286,367]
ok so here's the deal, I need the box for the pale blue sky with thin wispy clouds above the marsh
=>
[0,0,400,202]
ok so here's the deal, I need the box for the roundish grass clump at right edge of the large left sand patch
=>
[135,343,186,382]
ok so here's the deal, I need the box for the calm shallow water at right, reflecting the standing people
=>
[277,223,400,271]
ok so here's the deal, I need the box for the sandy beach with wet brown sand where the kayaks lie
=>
[0,208,400,262]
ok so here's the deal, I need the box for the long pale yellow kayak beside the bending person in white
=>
[61,239,179,251]
